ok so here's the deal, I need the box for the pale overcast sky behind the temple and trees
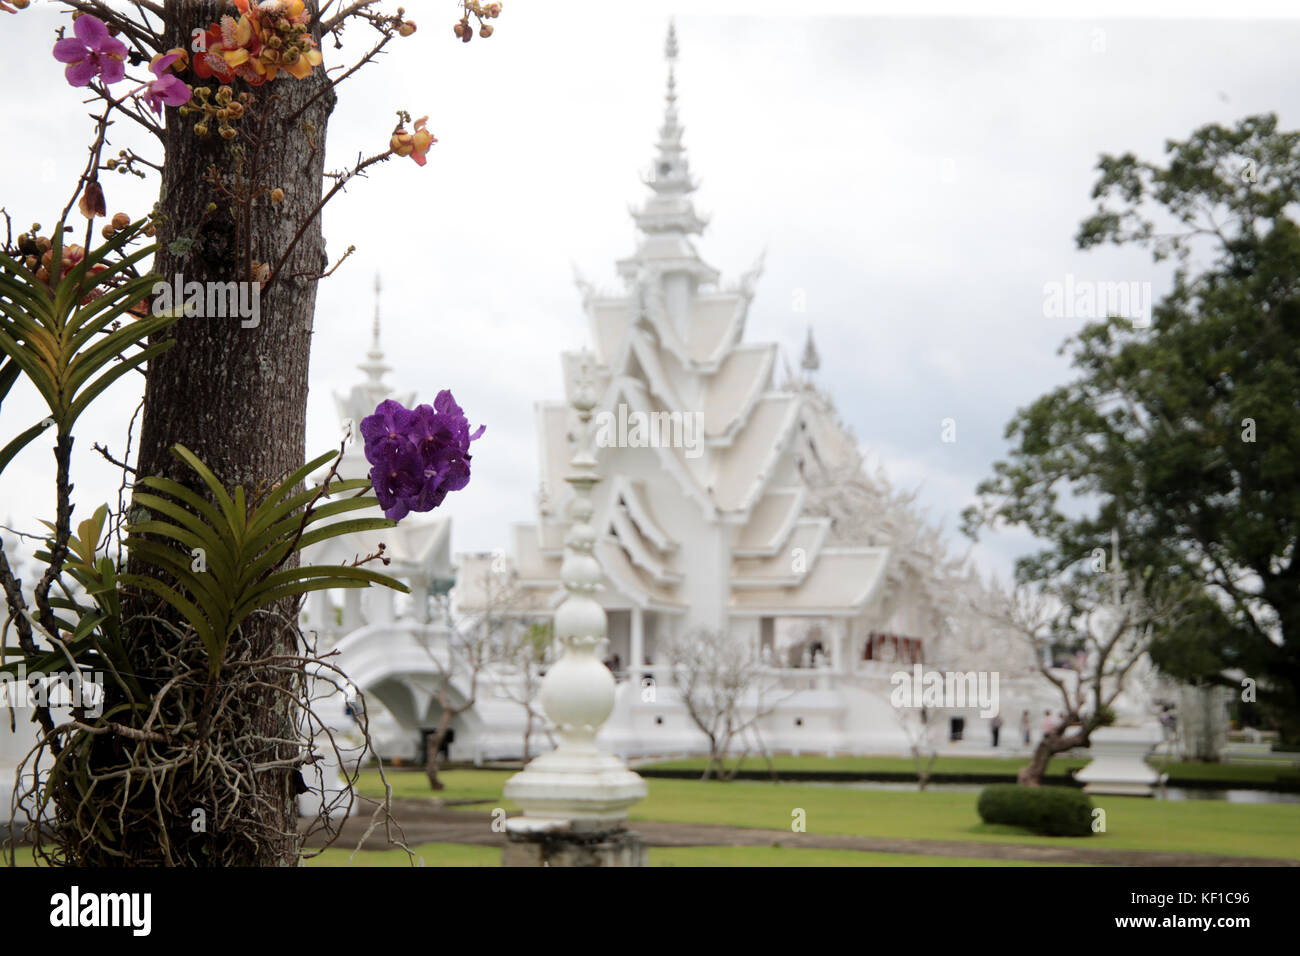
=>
[0,0,1300,580]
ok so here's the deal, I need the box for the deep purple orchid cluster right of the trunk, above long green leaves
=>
[361,389,486,520]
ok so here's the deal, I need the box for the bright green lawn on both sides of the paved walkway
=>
[10,757,1300,866]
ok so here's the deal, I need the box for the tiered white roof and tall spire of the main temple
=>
[460,27,888,615]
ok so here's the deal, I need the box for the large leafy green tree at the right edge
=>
[965,114,1300,740]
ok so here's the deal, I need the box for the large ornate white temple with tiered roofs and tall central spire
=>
[441,27,1041,757]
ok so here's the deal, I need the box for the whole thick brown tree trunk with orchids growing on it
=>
[113,0,334,866]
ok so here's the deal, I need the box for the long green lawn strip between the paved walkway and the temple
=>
[361,770,1300,858]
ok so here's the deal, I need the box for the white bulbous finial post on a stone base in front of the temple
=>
[504,352,646,866]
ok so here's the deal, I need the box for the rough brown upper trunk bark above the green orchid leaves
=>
[138,0,334,502]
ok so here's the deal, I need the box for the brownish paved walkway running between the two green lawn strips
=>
[312,800,1300,866]
